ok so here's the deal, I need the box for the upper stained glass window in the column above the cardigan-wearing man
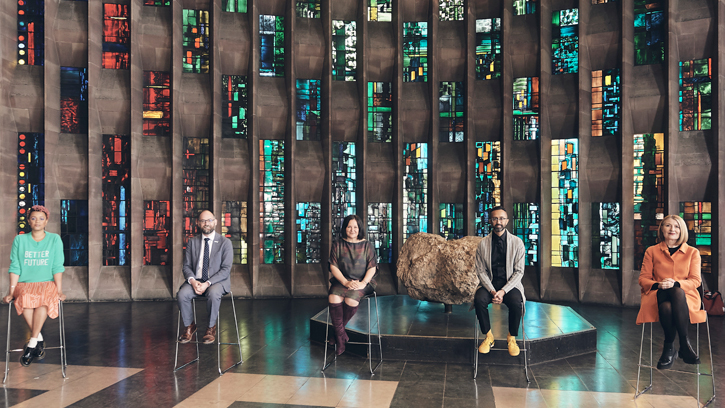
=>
[476,18,503,79]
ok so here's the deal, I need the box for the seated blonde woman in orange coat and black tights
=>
[637,215,706,370]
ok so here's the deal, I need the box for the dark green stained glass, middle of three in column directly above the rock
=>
[438,82,466,142]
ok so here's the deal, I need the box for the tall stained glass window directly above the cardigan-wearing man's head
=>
[474,142,503,237]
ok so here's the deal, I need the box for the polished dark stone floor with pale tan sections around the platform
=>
[0,299,725,408]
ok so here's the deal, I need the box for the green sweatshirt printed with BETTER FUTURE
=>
[8,231,65,282]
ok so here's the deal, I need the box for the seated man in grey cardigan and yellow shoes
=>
[473,206,526,356]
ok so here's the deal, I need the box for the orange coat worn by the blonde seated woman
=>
[637,242,707,324]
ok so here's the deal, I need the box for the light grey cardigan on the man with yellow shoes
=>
[476,232,526,302]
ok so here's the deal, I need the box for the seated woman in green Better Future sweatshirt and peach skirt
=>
[3,205,65,366]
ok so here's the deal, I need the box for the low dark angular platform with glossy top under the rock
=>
[310,295,597,365]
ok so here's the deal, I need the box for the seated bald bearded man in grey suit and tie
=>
[176,210,234,344]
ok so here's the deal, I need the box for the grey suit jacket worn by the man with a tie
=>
[183,233,234,292]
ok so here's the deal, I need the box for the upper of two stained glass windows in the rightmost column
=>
[680,58,712,131]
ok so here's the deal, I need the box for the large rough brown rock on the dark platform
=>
[398,232,483,305]
